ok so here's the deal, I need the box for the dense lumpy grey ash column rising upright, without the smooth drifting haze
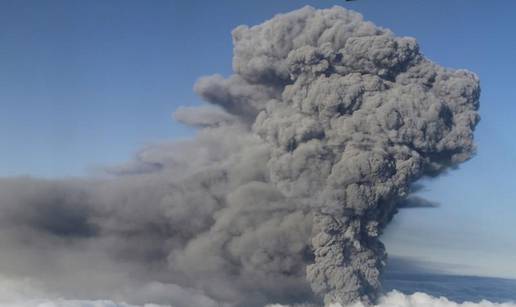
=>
[196,7,480,304]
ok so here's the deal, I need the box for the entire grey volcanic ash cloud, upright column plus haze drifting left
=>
[0,7,480,307]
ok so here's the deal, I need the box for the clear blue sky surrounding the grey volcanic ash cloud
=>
[0,0,516,277]
